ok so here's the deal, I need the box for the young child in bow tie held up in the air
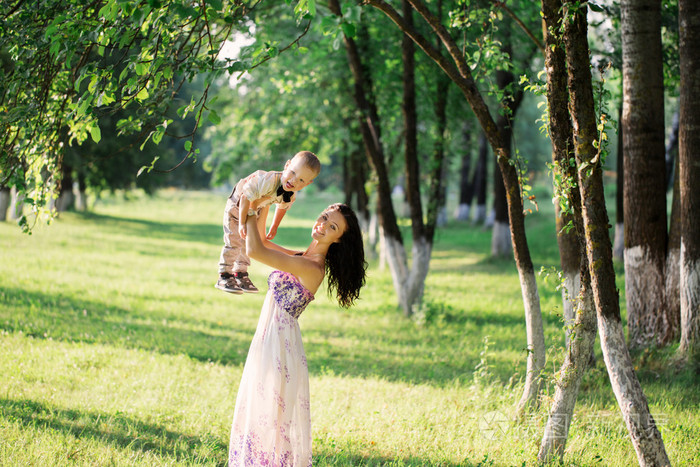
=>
[215,151,321,294]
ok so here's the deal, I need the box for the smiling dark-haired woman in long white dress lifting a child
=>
[229,204,367,467]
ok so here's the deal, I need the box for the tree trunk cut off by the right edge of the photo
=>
[678,0,700,361]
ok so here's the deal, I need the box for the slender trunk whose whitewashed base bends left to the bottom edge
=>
[537,0,597,463]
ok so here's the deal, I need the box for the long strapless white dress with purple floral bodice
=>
[228,271,314,467]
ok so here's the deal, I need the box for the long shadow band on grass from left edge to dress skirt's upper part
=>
[0,287,255,365]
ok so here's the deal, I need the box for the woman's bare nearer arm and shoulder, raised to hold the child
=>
[246,216,325,293]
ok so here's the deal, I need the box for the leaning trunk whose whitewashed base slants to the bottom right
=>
[564,3,670,466]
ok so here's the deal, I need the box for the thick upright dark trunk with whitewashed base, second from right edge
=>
[621,0,668,348]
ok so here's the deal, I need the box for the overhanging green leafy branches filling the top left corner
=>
[0,0,274,229]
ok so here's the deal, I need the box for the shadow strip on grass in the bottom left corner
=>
[0,399,228,465]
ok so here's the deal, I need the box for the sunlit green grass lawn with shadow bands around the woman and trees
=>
[0,190,700,466]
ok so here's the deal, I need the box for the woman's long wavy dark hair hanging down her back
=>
[326,203,367,308]
